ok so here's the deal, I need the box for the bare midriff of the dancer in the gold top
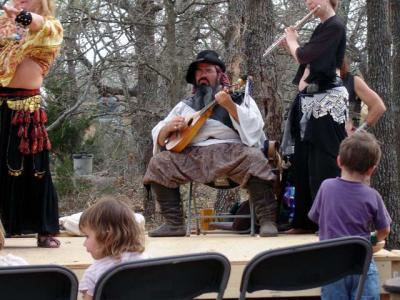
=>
[7,58,43,90]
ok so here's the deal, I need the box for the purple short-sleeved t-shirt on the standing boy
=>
[308,178,392,240]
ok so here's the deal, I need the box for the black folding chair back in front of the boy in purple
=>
[240,237,372,299]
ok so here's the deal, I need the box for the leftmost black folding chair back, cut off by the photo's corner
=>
[0,265,78,300]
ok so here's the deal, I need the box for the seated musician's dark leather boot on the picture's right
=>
[246,177,278,236]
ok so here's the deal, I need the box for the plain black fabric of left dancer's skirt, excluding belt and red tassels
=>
[0,97,59,235]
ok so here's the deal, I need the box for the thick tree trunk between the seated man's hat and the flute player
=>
[244,0,283,140]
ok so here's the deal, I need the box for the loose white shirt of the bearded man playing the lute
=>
[151,95,266,154]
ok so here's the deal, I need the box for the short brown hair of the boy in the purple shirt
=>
[339,130,381,174]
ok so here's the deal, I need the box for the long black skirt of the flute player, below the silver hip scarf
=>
[291,95,347,230]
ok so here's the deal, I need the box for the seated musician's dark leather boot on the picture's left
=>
[149,183,186,237]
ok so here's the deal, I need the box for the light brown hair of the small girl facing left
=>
[79,197,144,258]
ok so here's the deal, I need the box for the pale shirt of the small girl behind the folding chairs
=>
[79,252,149,296]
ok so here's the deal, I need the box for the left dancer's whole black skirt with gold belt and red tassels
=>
[0,88,59,234]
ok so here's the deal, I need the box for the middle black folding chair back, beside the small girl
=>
[93,253,230,300]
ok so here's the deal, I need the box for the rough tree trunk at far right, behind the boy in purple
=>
[367,0,400,249]
